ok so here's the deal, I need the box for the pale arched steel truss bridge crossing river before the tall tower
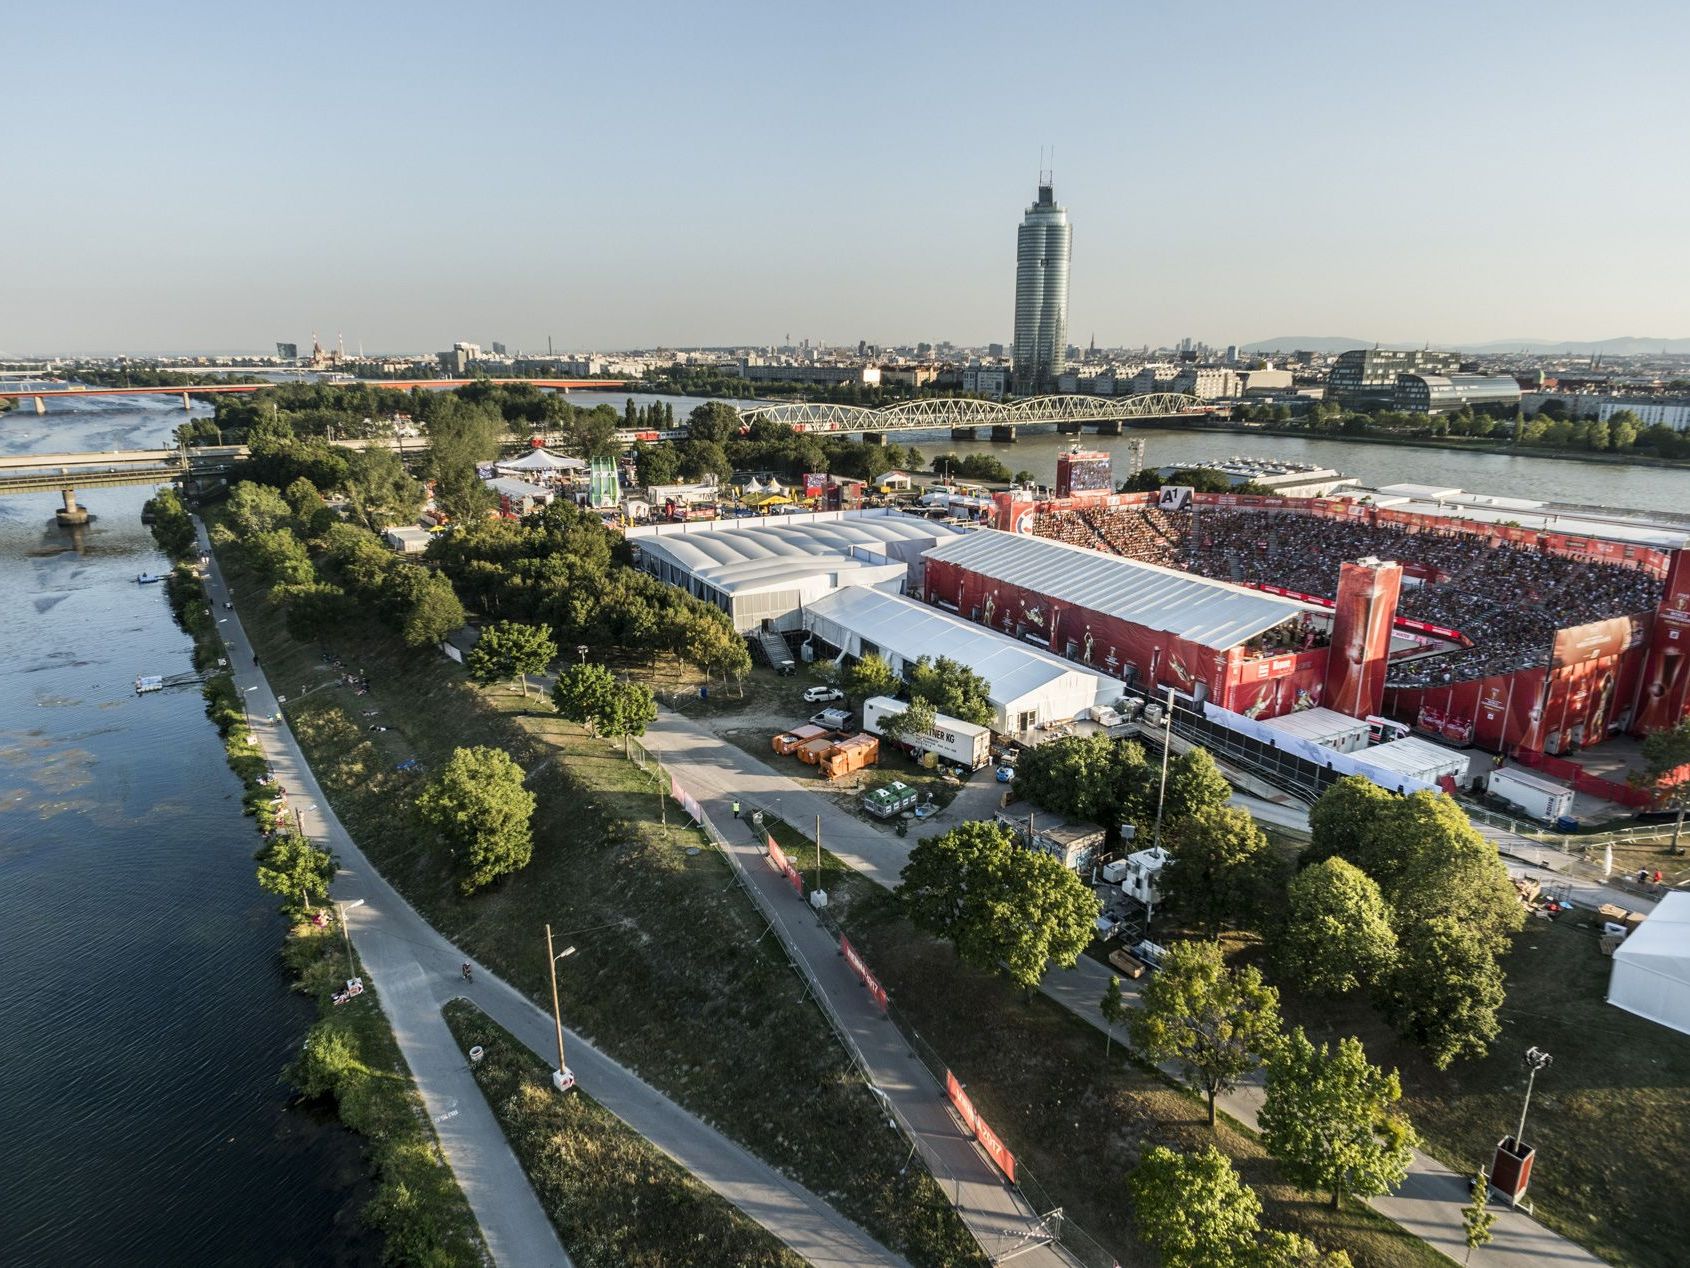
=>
[740,392,1224,441]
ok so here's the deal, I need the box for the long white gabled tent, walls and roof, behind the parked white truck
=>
[803,588,1120,735]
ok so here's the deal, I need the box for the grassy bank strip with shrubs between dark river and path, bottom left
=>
[284,925,492,1268]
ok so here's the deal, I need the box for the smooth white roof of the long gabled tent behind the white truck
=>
[804,585,1107,713]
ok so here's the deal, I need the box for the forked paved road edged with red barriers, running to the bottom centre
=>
[644,712,1071,1265]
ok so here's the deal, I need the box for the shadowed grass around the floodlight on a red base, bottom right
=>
[1237,916,1690,1268]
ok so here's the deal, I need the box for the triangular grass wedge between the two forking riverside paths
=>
[446,999,804,1268]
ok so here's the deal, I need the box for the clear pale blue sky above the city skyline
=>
[0,0,1690,355]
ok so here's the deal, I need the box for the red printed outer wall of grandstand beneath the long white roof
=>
[926,560,1327,719]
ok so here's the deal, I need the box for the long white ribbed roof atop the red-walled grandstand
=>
[926,529,1325,649]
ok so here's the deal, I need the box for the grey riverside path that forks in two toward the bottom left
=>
[201,534,904,1268]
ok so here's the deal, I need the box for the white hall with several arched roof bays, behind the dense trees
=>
[627,509,957,634]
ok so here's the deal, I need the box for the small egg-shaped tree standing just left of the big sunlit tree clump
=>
[1274,855,1396,996]
